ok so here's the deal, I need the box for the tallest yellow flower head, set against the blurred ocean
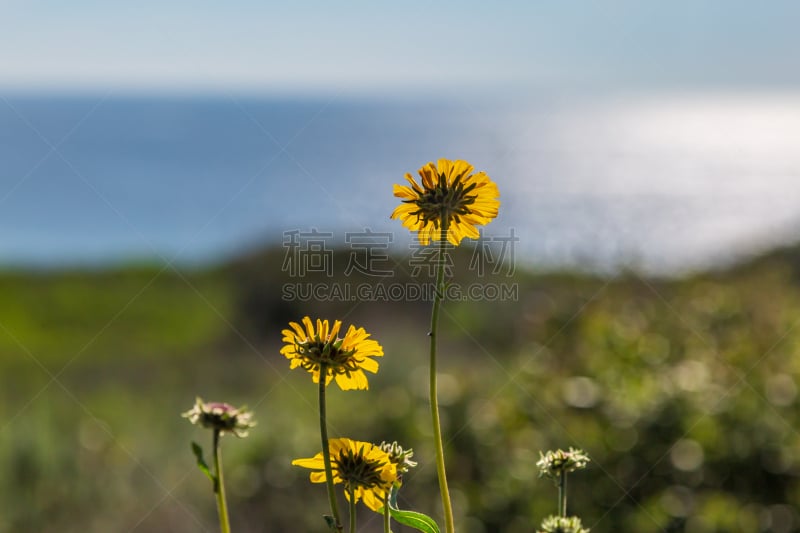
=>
[391,159,500,246]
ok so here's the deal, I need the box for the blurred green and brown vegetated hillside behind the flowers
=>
[0,242,800,533]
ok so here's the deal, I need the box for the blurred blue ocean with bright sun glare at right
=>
[0,93,800,273]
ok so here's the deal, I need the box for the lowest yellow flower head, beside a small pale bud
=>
[292,438,397,512]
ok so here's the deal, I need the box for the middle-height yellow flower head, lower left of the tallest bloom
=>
[281,317,383,390]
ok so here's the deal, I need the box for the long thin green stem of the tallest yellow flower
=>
[428,219,455,533]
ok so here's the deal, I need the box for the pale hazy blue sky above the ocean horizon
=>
[0,0,800,93]
